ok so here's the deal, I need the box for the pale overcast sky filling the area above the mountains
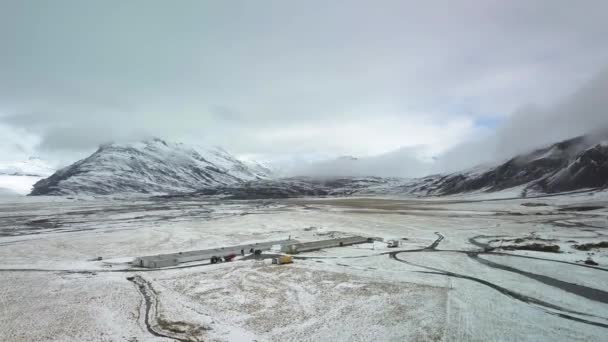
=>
[0,0,608,172]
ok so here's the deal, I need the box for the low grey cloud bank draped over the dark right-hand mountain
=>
[296,69,608,177]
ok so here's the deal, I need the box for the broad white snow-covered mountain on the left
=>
[31,138,270,195]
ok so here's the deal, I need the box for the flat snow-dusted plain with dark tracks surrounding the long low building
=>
[0,192,608,341]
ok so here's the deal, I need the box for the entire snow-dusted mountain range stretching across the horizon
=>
[25,135,608,198]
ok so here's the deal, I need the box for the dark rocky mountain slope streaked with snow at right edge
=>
[410,136,608,196]
